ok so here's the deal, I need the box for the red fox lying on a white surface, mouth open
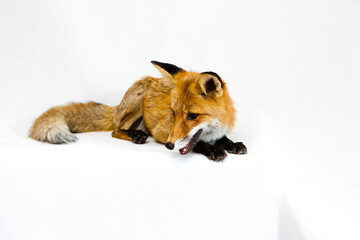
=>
[29,61,247,161]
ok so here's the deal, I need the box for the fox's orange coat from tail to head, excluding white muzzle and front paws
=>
[29,62,235,146]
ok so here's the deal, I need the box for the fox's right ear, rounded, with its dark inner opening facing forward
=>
[199,72,223,97]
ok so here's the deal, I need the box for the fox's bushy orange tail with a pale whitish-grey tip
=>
[29,102,116,144]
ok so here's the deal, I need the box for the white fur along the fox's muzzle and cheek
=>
[175,120,227,150]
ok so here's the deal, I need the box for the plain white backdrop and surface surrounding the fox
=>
[0,0,360,240]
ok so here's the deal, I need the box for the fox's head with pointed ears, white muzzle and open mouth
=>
[152,61,235,154]
